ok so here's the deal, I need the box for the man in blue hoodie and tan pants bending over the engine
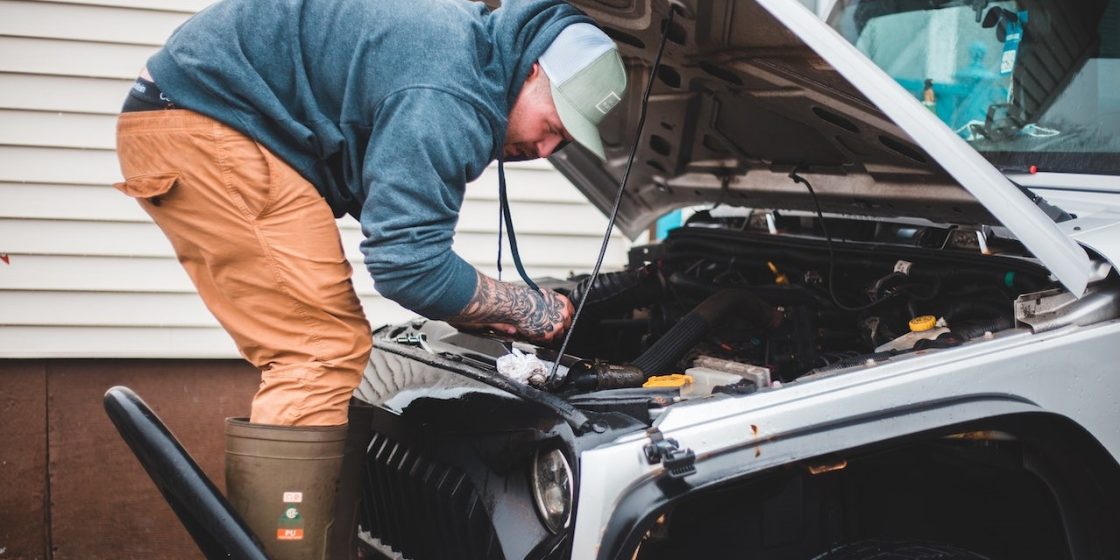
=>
[109,0,626,559]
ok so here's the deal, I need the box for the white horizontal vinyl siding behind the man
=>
[0,0,628,358]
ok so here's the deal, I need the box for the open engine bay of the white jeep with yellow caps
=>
[371,208,1055,421]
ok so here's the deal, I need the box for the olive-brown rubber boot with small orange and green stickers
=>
[225,418,347,560]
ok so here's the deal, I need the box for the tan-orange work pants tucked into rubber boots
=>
[115,110,372,426]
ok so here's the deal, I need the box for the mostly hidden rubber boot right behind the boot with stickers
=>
[328,400,373,560]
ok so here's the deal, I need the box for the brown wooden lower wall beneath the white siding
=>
[0,360,259,560]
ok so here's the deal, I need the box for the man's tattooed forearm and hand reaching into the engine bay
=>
[448,269,576,344]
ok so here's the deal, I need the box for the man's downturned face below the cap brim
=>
[502,64,571,161]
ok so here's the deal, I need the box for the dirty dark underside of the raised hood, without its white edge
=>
[552,0,997,236]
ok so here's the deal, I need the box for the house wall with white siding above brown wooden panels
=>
[0,0,628,560]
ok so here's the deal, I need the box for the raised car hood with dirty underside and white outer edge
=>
[551,0,1092,296]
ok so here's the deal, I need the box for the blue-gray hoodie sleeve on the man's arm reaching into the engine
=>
[360,88,494,318]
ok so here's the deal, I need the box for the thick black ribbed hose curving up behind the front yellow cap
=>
[632,289,782,379]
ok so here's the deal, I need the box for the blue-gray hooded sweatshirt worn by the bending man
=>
[148,0,590,318]
